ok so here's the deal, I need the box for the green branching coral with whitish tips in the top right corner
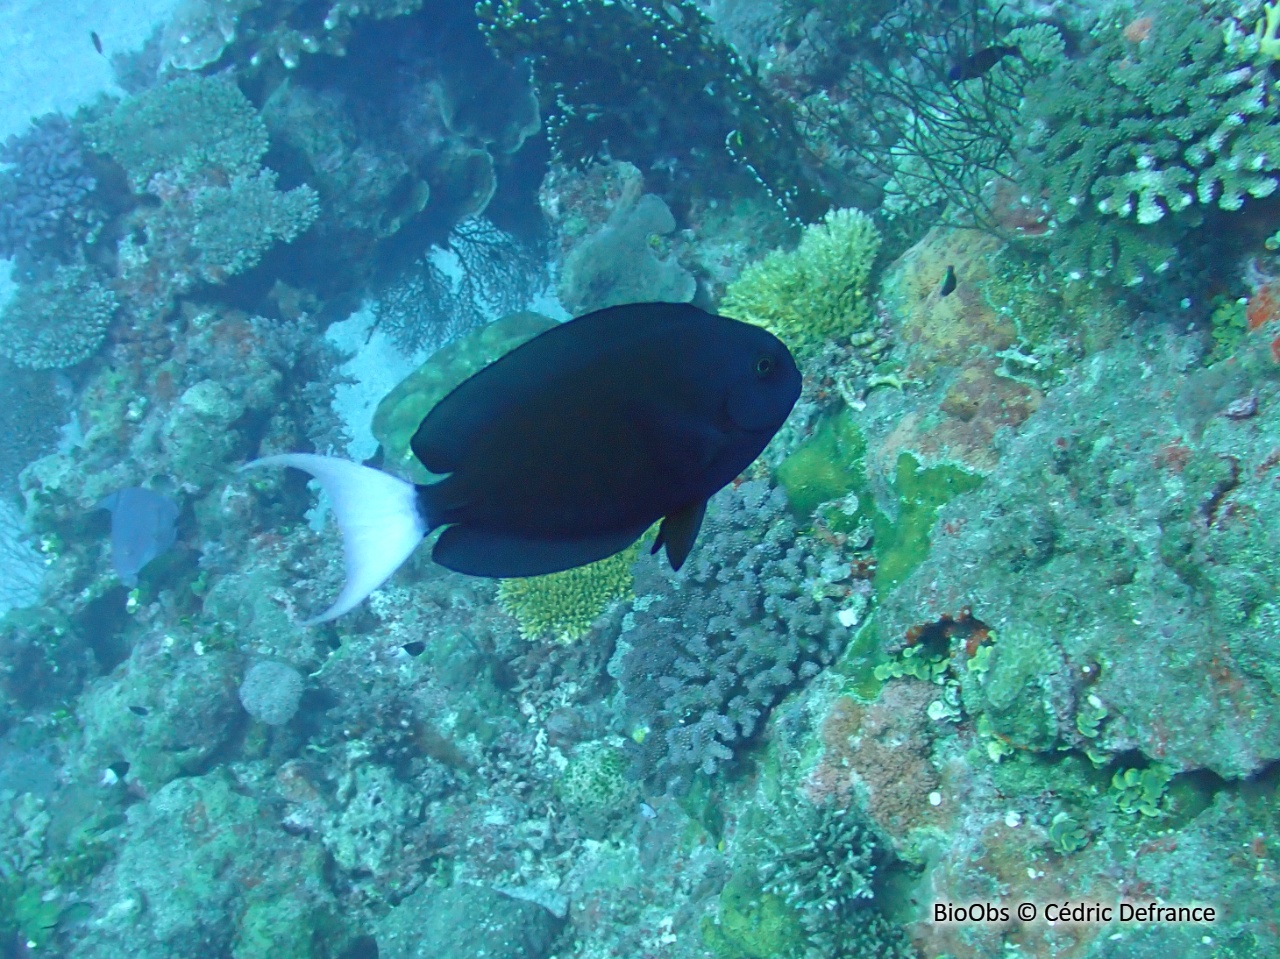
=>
[1016,4,1280,284]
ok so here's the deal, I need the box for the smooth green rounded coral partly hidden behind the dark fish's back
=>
[372,311,557,483]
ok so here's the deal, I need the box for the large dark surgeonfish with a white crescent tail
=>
[244,303,800,624]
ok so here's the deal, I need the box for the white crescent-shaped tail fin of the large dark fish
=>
[241,453,429,626]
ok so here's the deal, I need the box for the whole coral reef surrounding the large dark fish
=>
[0,0,1280,959]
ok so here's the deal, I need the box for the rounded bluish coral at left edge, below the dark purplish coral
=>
[0,266,118,370]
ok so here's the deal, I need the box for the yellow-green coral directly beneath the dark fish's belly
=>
[498,543,640,643]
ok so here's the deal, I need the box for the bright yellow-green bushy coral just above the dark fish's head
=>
[719,209,881,357]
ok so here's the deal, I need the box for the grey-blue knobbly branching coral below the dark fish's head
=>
[618,480,847,787]
